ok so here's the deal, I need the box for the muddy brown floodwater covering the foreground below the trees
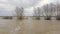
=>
[0,19,60,34]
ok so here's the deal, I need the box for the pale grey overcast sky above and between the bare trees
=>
[0,0,60,15]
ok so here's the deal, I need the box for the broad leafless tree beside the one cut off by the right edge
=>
[43,3,55,20]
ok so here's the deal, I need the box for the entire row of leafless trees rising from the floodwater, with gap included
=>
[15,2,60,20]
